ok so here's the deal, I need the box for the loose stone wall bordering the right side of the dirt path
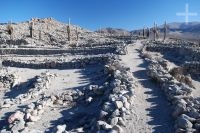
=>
[148,60,200,133]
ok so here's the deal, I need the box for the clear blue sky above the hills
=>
[0,0,200,30]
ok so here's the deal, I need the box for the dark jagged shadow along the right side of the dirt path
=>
[133,53,174,133]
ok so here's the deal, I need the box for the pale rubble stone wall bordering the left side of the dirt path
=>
[68,59,135,133]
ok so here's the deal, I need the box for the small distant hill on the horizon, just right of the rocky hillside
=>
[96,27,130,36]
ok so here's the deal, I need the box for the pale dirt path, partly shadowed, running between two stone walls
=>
[121,41,173,133]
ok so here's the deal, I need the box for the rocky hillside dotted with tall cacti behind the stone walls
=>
[0,18,110,47]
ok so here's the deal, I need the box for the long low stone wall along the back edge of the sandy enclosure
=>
[2,55,112,69]
